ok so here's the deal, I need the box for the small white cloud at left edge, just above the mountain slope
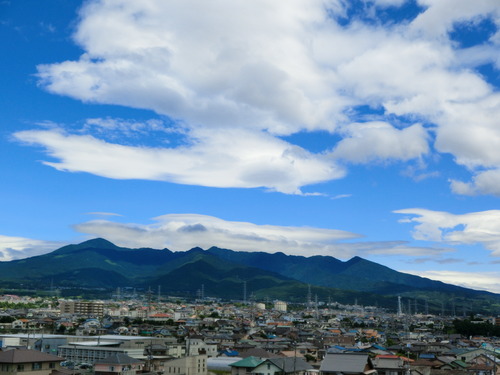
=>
[0,235,63,262]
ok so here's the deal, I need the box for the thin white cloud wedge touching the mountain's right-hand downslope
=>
[401,270,500,293]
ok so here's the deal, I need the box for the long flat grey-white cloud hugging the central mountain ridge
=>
[70,214,449,259]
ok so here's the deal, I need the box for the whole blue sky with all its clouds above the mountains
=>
[0,0,500,293]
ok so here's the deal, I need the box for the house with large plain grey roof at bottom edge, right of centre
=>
[319,353,377,375]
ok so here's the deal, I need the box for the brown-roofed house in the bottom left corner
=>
[0,348,64,375]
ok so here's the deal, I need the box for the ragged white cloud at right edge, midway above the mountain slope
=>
[394,208,500,256]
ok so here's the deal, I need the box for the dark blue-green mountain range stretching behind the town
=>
[0,238,500,314]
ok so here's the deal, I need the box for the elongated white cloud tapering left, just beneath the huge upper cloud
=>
[15,129,344,194]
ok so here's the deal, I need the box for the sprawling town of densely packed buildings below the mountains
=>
[0,293,500,375]
